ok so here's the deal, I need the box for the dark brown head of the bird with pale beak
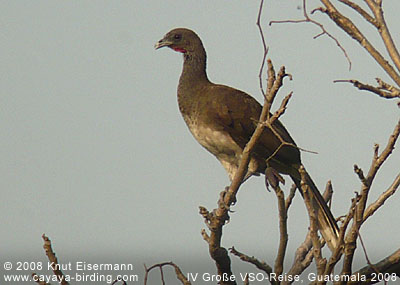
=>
[154,28,203,54]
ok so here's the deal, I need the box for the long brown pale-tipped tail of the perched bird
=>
[291,169,339,252]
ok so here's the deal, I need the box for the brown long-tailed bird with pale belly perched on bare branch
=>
[155,28,339,251]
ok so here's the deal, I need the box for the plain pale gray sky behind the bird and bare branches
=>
[0,0,400,284]
